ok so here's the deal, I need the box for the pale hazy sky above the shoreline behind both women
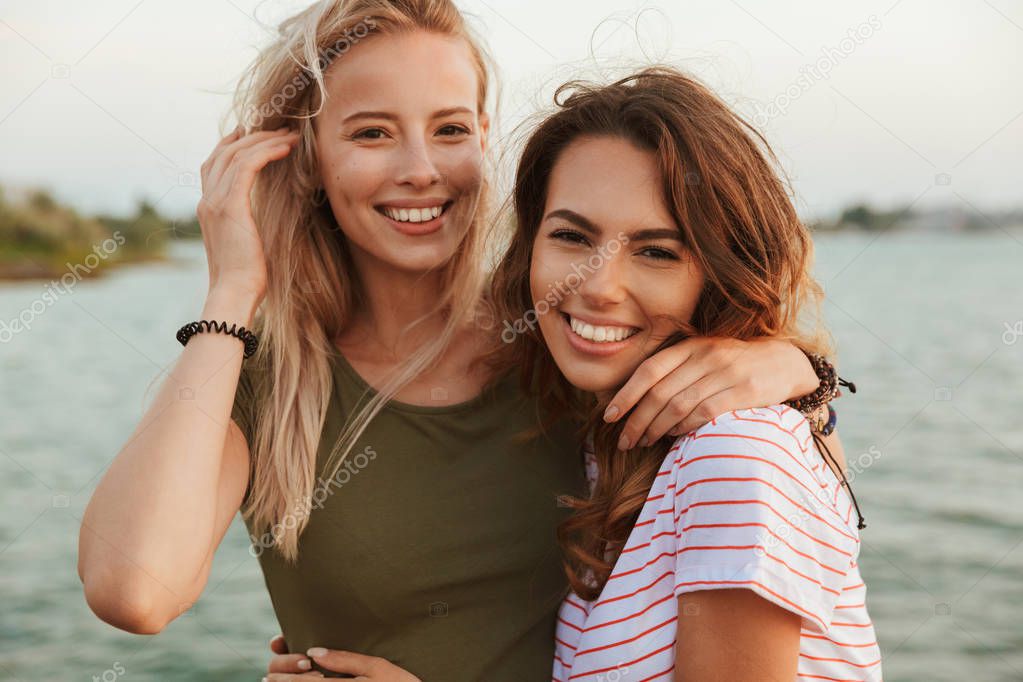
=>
[0,0,1023,217]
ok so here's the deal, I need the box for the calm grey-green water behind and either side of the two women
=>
[0,231,1023,682]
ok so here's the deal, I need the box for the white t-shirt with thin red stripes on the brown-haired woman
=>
[553,405,881,682]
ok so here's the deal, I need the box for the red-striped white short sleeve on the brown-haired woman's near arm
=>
[671,405,859,633]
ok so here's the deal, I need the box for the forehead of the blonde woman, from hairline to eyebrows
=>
[322,31,479,117]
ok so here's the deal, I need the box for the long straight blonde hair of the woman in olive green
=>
[232,0,491,561]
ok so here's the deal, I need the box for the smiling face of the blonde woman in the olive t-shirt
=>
[315,31,487,271]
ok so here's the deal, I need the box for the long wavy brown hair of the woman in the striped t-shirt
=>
[489,66,831,599]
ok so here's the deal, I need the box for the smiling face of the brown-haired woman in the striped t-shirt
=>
[530,136,704,393]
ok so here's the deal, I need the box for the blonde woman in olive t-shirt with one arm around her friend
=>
[79,0,830,680]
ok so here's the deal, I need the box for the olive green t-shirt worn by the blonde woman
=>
[232,352,585,682]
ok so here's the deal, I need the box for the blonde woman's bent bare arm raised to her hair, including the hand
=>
[78,130,296,634]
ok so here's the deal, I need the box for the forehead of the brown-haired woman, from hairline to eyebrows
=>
[546,136,674,229]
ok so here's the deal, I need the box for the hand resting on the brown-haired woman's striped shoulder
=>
[605,336,819,450]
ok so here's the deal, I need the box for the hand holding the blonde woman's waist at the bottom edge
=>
[264,635,420,682]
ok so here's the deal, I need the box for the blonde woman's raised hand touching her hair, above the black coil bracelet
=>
[195,127,299,299]
